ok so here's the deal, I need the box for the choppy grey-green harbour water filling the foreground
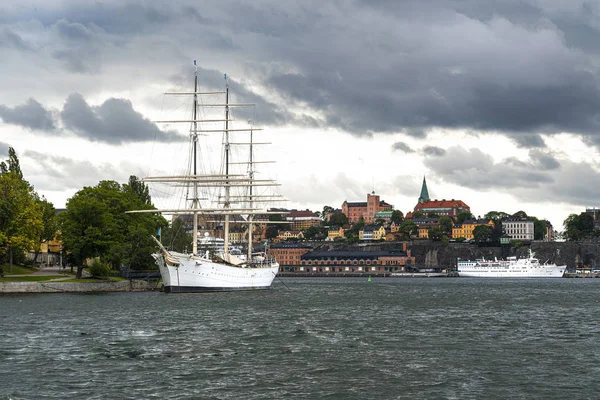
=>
[0,278,600,399]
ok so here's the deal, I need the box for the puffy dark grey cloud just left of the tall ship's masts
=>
[60,93,173,144]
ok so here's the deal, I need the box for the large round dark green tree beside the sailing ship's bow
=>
[59,181,166,278]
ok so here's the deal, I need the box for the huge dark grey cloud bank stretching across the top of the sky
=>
[5,0,600,148]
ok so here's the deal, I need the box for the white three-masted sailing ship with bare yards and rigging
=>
[127,61,284,293]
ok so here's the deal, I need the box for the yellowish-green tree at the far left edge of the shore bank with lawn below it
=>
[0,147,43,273]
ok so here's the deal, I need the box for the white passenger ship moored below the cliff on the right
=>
[457,249,567,278]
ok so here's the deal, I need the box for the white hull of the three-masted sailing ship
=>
[155,253,279,293]
